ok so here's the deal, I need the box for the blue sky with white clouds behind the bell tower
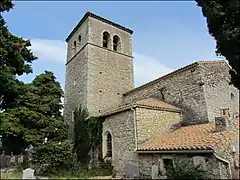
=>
[4,1,222,88]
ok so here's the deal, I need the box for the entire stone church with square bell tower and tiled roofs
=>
[64,12,239,179]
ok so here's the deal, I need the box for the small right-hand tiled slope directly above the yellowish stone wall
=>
[135,98,181,111]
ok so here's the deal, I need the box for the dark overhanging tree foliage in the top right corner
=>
[196,0,240,89]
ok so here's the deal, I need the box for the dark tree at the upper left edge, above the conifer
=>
[0,0,36,111]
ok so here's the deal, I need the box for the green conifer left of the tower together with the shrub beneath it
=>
[1,71,72,174]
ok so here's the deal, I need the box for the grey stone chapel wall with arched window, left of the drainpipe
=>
[103,110,137,175]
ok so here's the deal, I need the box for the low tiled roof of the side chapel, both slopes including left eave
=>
[101,98,181,116]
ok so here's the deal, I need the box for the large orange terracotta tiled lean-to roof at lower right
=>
[138,120,239,151]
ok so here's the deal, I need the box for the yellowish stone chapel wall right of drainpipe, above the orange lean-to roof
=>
[136,108,181,144]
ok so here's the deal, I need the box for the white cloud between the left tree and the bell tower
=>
[31,39,67,63]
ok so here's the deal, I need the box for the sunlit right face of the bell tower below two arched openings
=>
[87,17,133,115]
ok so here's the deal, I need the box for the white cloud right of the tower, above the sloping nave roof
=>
[133,53,173,86]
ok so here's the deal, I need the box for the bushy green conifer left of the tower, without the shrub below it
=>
[1,71,68,153]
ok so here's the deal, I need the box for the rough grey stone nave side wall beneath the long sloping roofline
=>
[123,65,208,124]
